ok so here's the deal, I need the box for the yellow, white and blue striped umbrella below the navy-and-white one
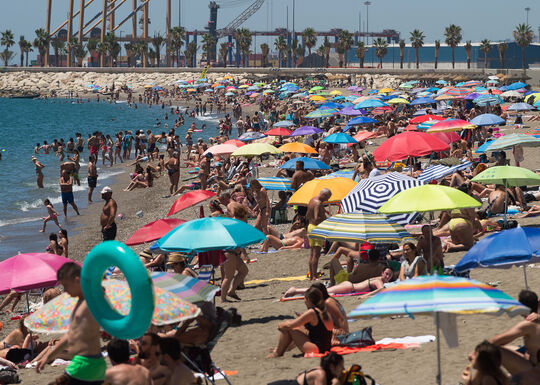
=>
[308,213,413,243]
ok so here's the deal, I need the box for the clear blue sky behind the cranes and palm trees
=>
[0,0,540,54]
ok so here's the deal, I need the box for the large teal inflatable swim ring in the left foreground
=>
[81,241,154,339]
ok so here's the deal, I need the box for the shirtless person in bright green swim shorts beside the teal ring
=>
[36,262,107,385]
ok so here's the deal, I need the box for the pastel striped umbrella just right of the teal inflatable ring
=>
[150,271,219,304]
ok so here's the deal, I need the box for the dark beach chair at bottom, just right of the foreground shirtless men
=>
[182,307,236,385]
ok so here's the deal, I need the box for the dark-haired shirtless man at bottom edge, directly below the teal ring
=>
[105,338,152,385]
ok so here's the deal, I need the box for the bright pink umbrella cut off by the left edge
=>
[0,253,78,294]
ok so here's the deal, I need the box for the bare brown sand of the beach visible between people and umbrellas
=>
[0,85,540,385]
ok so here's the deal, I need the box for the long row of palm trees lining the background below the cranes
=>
[0,24,534,69]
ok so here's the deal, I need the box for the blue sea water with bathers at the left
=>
[0,98,218,260]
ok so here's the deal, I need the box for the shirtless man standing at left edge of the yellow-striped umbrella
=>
[306,188,332,281]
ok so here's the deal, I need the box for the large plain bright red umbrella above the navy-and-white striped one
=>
[373,131,449,162]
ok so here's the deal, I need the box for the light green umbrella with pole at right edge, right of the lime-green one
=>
[471,165,540,223]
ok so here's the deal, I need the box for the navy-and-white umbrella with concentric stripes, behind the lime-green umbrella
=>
[341,172,422,225]
